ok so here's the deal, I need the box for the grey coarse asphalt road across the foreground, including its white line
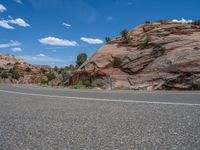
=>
[0,84,200,150]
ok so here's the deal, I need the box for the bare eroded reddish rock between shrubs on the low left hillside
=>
[0,55,50,84]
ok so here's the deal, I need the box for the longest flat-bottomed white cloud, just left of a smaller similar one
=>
[38,37,77,46]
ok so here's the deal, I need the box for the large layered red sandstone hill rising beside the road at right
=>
[70,21,200,90]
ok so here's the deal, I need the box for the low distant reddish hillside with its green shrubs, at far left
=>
[0,55,50,84]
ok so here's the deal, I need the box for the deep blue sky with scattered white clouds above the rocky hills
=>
[0,0,200,66]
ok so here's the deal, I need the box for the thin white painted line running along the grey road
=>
[0,90,200,106]
